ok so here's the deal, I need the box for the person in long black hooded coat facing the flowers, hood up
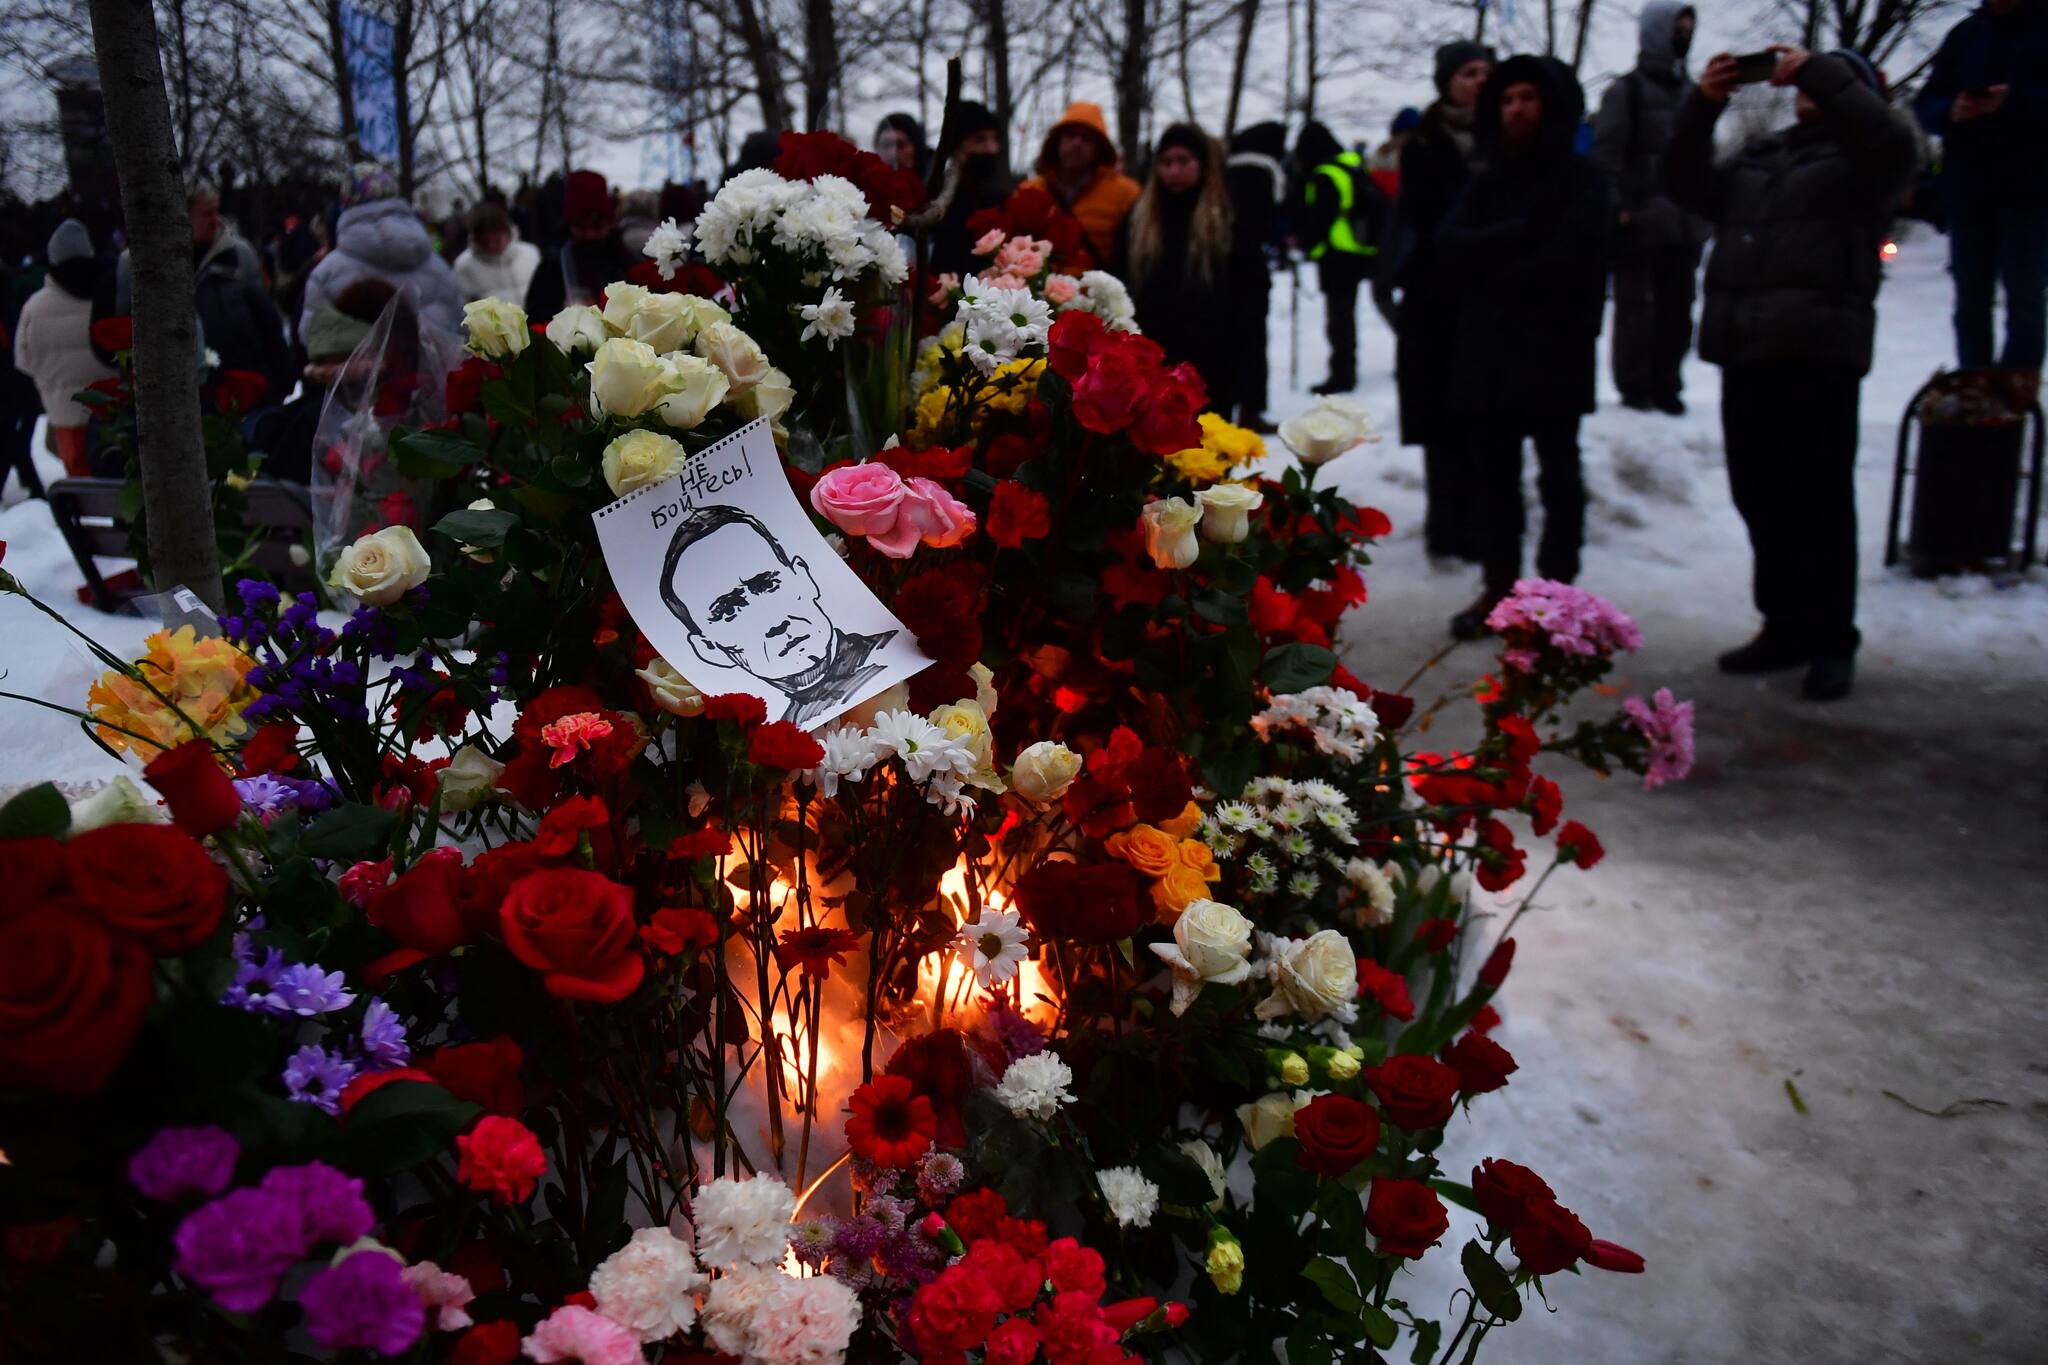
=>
[1441,48,1614,639]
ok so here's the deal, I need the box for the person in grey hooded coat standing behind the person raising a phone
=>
[1589,0,1706,415]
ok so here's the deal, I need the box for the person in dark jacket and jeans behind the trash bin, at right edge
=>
[1913,0,2048,405]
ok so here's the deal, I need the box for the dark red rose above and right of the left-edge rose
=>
[63,825,227,956]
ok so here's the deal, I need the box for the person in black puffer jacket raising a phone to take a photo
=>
[1665,47,1919,700]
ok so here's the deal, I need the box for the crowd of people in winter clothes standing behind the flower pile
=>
[0,0,2048,700]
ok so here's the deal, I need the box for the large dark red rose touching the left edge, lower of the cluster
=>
[0,896,154,1095]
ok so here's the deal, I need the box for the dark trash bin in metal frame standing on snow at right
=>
[1884,368,2042,577]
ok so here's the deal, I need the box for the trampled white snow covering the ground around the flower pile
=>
[0,224,2048,1365]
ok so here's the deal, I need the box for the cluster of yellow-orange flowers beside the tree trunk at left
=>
[86,626,256,759]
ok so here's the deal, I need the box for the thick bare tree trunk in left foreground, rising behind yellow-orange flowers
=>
[90,0,221,610]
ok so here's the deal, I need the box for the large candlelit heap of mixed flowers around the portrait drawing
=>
[0,130,1692,1365]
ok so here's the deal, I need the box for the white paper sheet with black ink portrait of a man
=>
[596,422,932,729]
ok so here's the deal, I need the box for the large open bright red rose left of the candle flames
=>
[498,868,647,1005]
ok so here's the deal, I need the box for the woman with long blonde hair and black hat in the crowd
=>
[1118,123,1231,395]
